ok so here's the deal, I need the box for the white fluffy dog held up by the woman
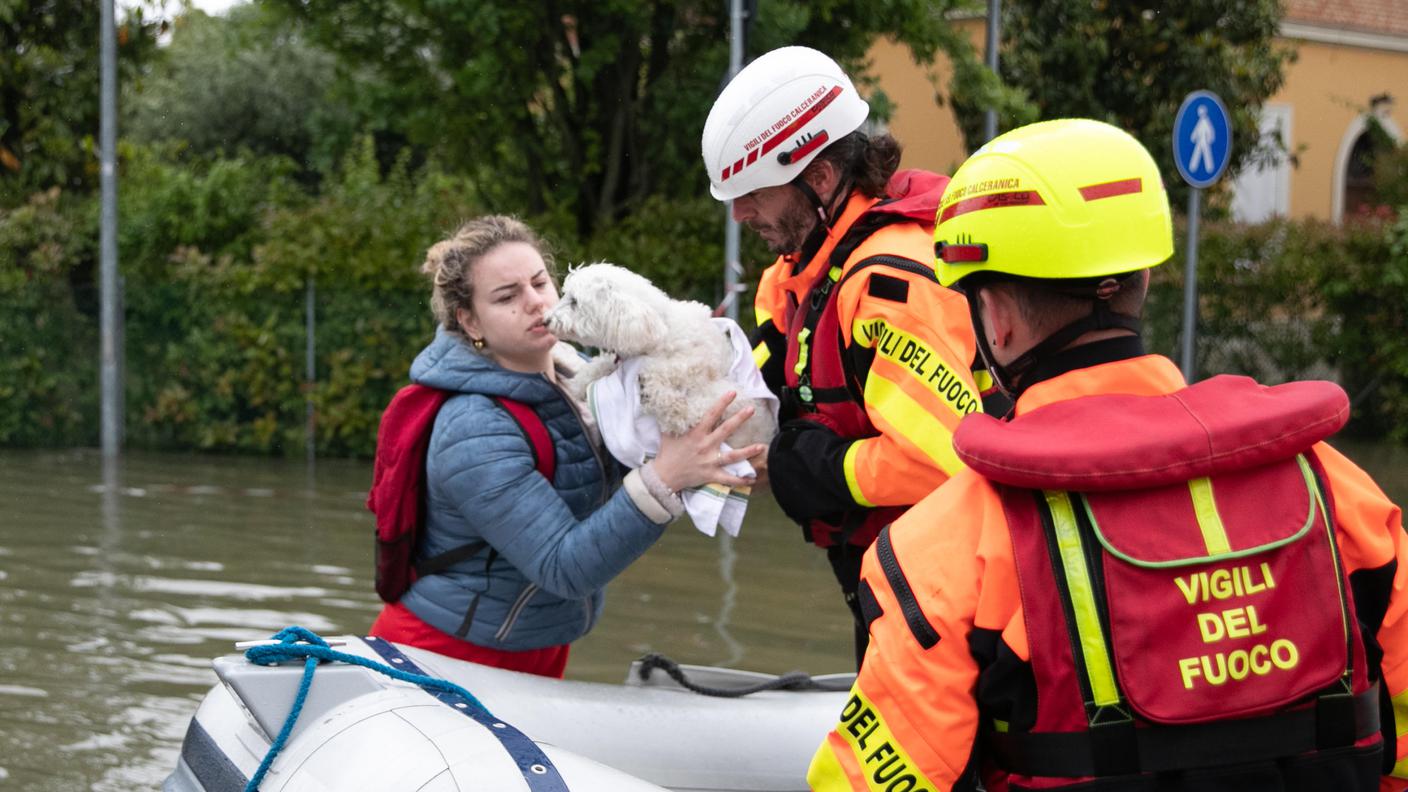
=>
[546,264,777,448]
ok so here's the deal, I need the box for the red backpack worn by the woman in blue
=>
[366,385,558,602]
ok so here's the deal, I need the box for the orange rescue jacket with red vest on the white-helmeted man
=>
[755,172,981,547]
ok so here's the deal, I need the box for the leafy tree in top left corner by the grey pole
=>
[0,0,159,206]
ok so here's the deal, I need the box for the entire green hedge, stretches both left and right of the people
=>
[8,142,1408,457]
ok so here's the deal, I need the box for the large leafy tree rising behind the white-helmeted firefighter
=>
[266,0,997,237]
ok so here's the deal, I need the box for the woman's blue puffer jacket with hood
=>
[401,331,665,651]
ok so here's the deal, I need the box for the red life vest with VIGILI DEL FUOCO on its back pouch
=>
[955,376,1380,788]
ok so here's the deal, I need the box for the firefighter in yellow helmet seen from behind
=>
[808,120,1408,791]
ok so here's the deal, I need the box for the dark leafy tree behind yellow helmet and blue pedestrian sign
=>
[955,0,1294,203]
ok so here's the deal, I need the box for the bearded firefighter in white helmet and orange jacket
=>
[701,47,981,662]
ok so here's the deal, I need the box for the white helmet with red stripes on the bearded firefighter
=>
[700,47,870,200]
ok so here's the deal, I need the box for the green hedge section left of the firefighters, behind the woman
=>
[0,141,765,457]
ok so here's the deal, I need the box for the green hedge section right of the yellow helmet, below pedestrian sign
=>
[1145,210,1408,443]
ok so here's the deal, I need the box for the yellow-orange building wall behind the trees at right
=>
[869,25,1408,220]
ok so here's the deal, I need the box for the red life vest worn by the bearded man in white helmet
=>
[783,171,948,547]
